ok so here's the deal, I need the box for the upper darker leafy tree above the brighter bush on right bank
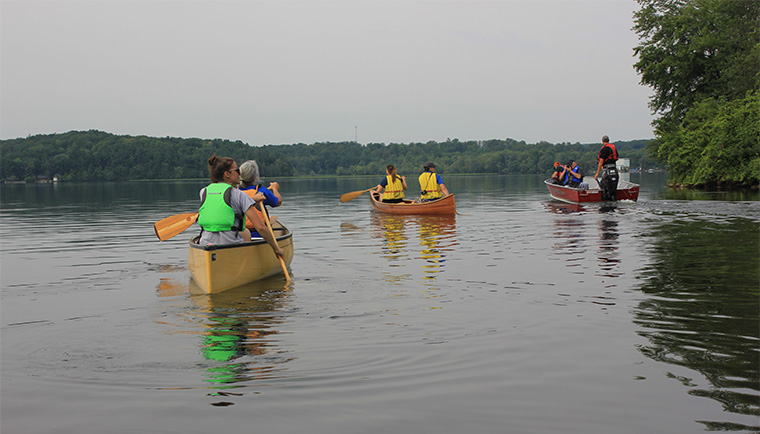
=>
[634,0,760,123]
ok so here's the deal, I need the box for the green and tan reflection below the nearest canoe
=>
[158,277,294,406]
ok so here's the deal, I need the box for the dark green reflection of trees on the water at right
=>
[634,218,760,431]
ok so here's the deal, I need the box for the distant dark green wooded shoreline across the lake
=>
[0,130,657,182]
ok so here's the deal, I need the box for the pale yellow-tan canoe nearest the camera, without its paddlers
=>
[187,221,293,294]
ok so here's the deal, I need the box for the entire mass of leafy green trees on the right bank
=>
[634,0,760,187]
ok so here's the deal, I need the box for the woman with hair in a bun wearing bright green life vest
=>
[198,155,284,256]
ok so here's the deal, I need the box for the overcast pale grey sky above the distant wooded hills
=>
[0,0,653,145]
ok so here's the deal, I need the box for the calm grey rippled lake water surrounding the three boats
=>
[0,174,760,434]
